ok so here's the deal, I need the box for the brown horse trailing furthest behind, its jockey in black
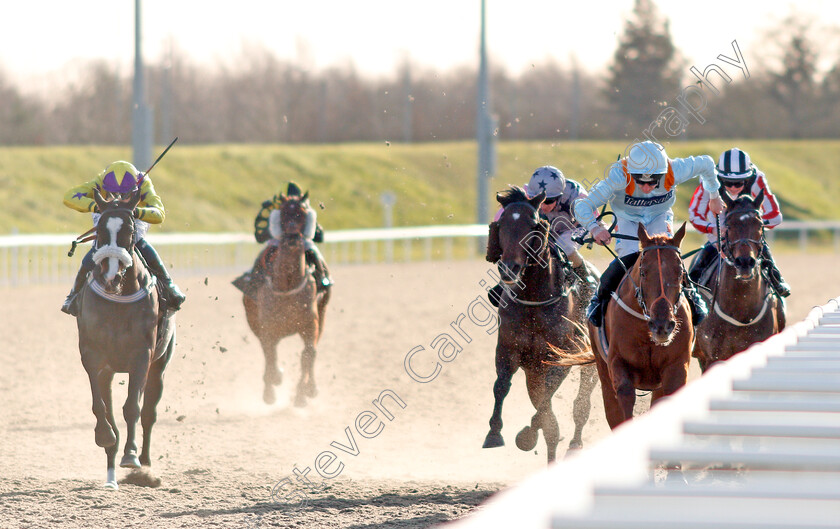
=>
[242,192,330,406]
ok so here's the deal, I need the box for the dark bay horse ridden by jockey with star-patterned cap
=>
[483,187,597,462]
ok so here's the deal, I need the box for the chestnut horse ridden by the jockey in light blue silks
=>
[589,224,694,428]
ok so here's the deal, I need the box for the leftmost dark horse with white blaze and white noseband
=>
[76,189,175,489]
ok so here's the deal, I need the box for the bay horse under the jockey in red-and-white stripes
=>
[693,189,785,372]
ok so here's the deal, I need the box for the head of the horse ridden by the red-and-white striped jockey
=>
[720,189,764,281]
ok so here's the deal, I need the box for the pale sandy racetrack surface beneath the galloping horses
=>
[0,255,840,528]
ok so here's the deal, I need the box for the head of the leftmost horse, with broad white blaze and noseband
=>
[93,188,140,293]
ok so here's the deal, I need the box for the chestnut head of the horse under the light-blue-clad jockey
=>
[634,223,685,345]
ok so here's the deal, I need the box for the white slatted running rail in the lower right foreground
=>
[446,298,840,529]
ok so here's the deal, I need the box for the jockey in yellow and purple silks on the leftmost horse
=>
[61,161,185,316]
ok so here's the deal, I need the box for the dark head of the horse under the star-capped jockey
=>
[488,187,549,284]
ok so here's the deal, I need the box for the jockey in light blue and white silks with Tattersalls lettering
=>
[574,141,724,327]
